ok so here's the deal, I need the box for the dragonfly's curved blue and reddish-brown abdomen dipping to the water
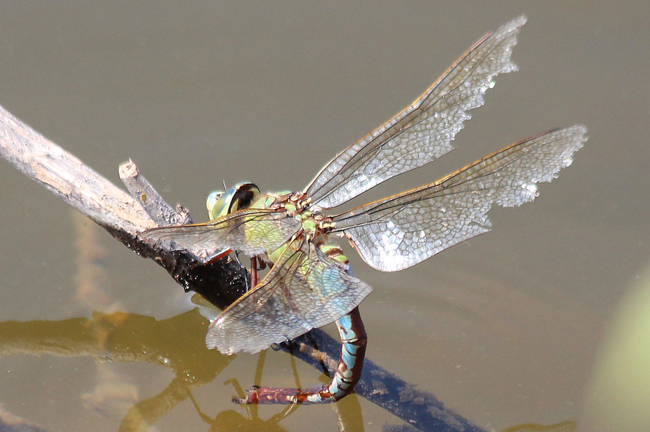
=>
[233,308,368,404]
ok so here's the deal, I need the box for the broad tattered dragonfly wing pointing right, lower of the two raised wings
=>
[333,126,587,271]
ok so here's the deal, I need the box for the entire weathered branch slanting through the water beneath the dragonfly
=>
[0,106,482,432]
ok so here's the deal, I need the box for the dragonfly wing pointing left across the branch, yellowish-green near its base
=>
[140,209,301,262]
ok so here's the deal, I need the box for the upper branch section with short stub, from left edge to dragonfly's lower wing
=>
[0,106,246,308]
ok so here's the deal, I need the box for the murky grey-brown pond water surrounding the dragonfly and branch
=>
[0,1,650,431]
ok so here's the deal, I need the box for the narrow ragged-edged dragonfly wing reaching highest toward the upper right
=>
[305,16,526,208]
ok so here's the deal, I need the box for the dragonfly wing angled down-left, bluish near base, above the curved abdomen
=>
[206,239,372,354]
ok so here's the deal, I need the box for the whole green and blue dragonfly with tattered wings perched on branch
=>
[142,17,587,403]
